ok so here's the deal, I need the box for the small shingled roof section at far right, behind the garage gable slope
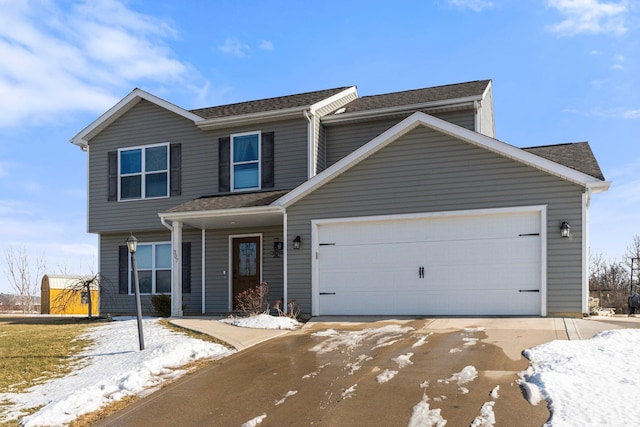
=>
[523,142,605,181]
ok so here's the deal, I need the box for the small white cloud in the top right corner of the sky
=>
[547,0,629,36]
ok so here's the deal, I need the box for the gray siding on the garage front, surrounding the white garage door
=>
[287,127,583,314]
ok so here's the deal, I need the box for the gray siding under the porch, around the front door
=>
[204,227,284,314]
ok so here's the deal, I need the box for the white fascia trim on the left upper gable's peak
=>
[71,89,204,149]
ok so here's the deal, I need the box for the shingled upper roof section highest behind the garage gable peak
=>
[336,80,491,113]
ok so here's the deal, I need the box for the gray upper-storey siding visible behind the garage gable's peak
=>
[324,110,475,168]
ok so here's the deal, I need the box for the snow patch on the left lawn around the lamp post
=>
[0,318,233,426]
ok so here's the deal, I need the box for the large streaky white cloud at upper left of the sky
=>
[0,0,204,127]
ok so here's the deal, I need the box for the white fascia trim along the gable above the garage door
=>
[272,112,609,207]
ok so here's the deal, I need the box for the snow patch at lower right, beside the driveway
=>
[521,329,640,427]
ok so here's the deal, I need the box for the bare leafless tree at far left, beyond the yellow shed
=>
[5,246,46,313]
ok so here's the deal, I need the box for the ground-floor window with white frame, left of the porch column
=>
[129,243,171,294]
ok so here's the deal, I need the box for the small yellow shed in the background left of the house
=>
[40,274,100,316]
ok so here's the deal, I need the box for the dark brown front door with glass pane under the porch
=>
[232,236,261,310]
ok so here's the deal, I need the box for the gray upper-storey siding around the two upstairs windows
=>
[88,101,307,233]
